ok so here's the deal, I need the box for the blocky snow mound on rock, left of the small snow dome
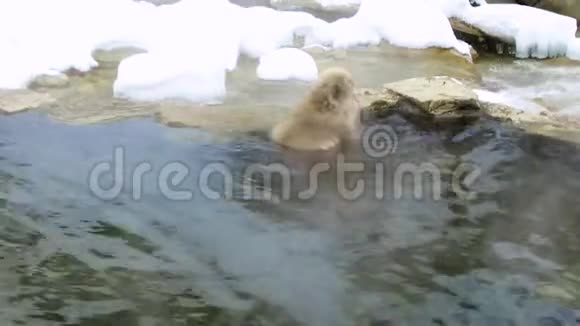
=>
[113,53,226,103]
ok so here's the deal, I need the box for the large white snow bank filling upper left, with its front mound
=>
[0,0,326,101]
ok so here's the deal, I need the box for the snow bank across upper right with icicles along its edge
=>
[306,0,580,59]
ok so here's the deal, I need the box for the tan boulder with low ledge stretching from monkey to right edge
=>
[356,76,580,133]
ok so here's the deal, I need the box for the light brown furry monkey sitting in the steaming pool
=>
[271,67,361,151]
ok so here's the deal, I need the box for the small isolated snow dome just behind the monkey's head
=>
[256,48,318,81]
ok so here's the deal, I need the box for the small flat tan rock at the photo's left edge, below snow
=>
[0,90,55,113]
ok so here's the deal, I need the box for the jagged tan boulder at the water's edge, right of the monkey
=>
[358,77,482,123]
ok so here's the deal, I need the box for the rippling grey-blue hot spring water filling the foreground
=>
[0,113,580,326]
